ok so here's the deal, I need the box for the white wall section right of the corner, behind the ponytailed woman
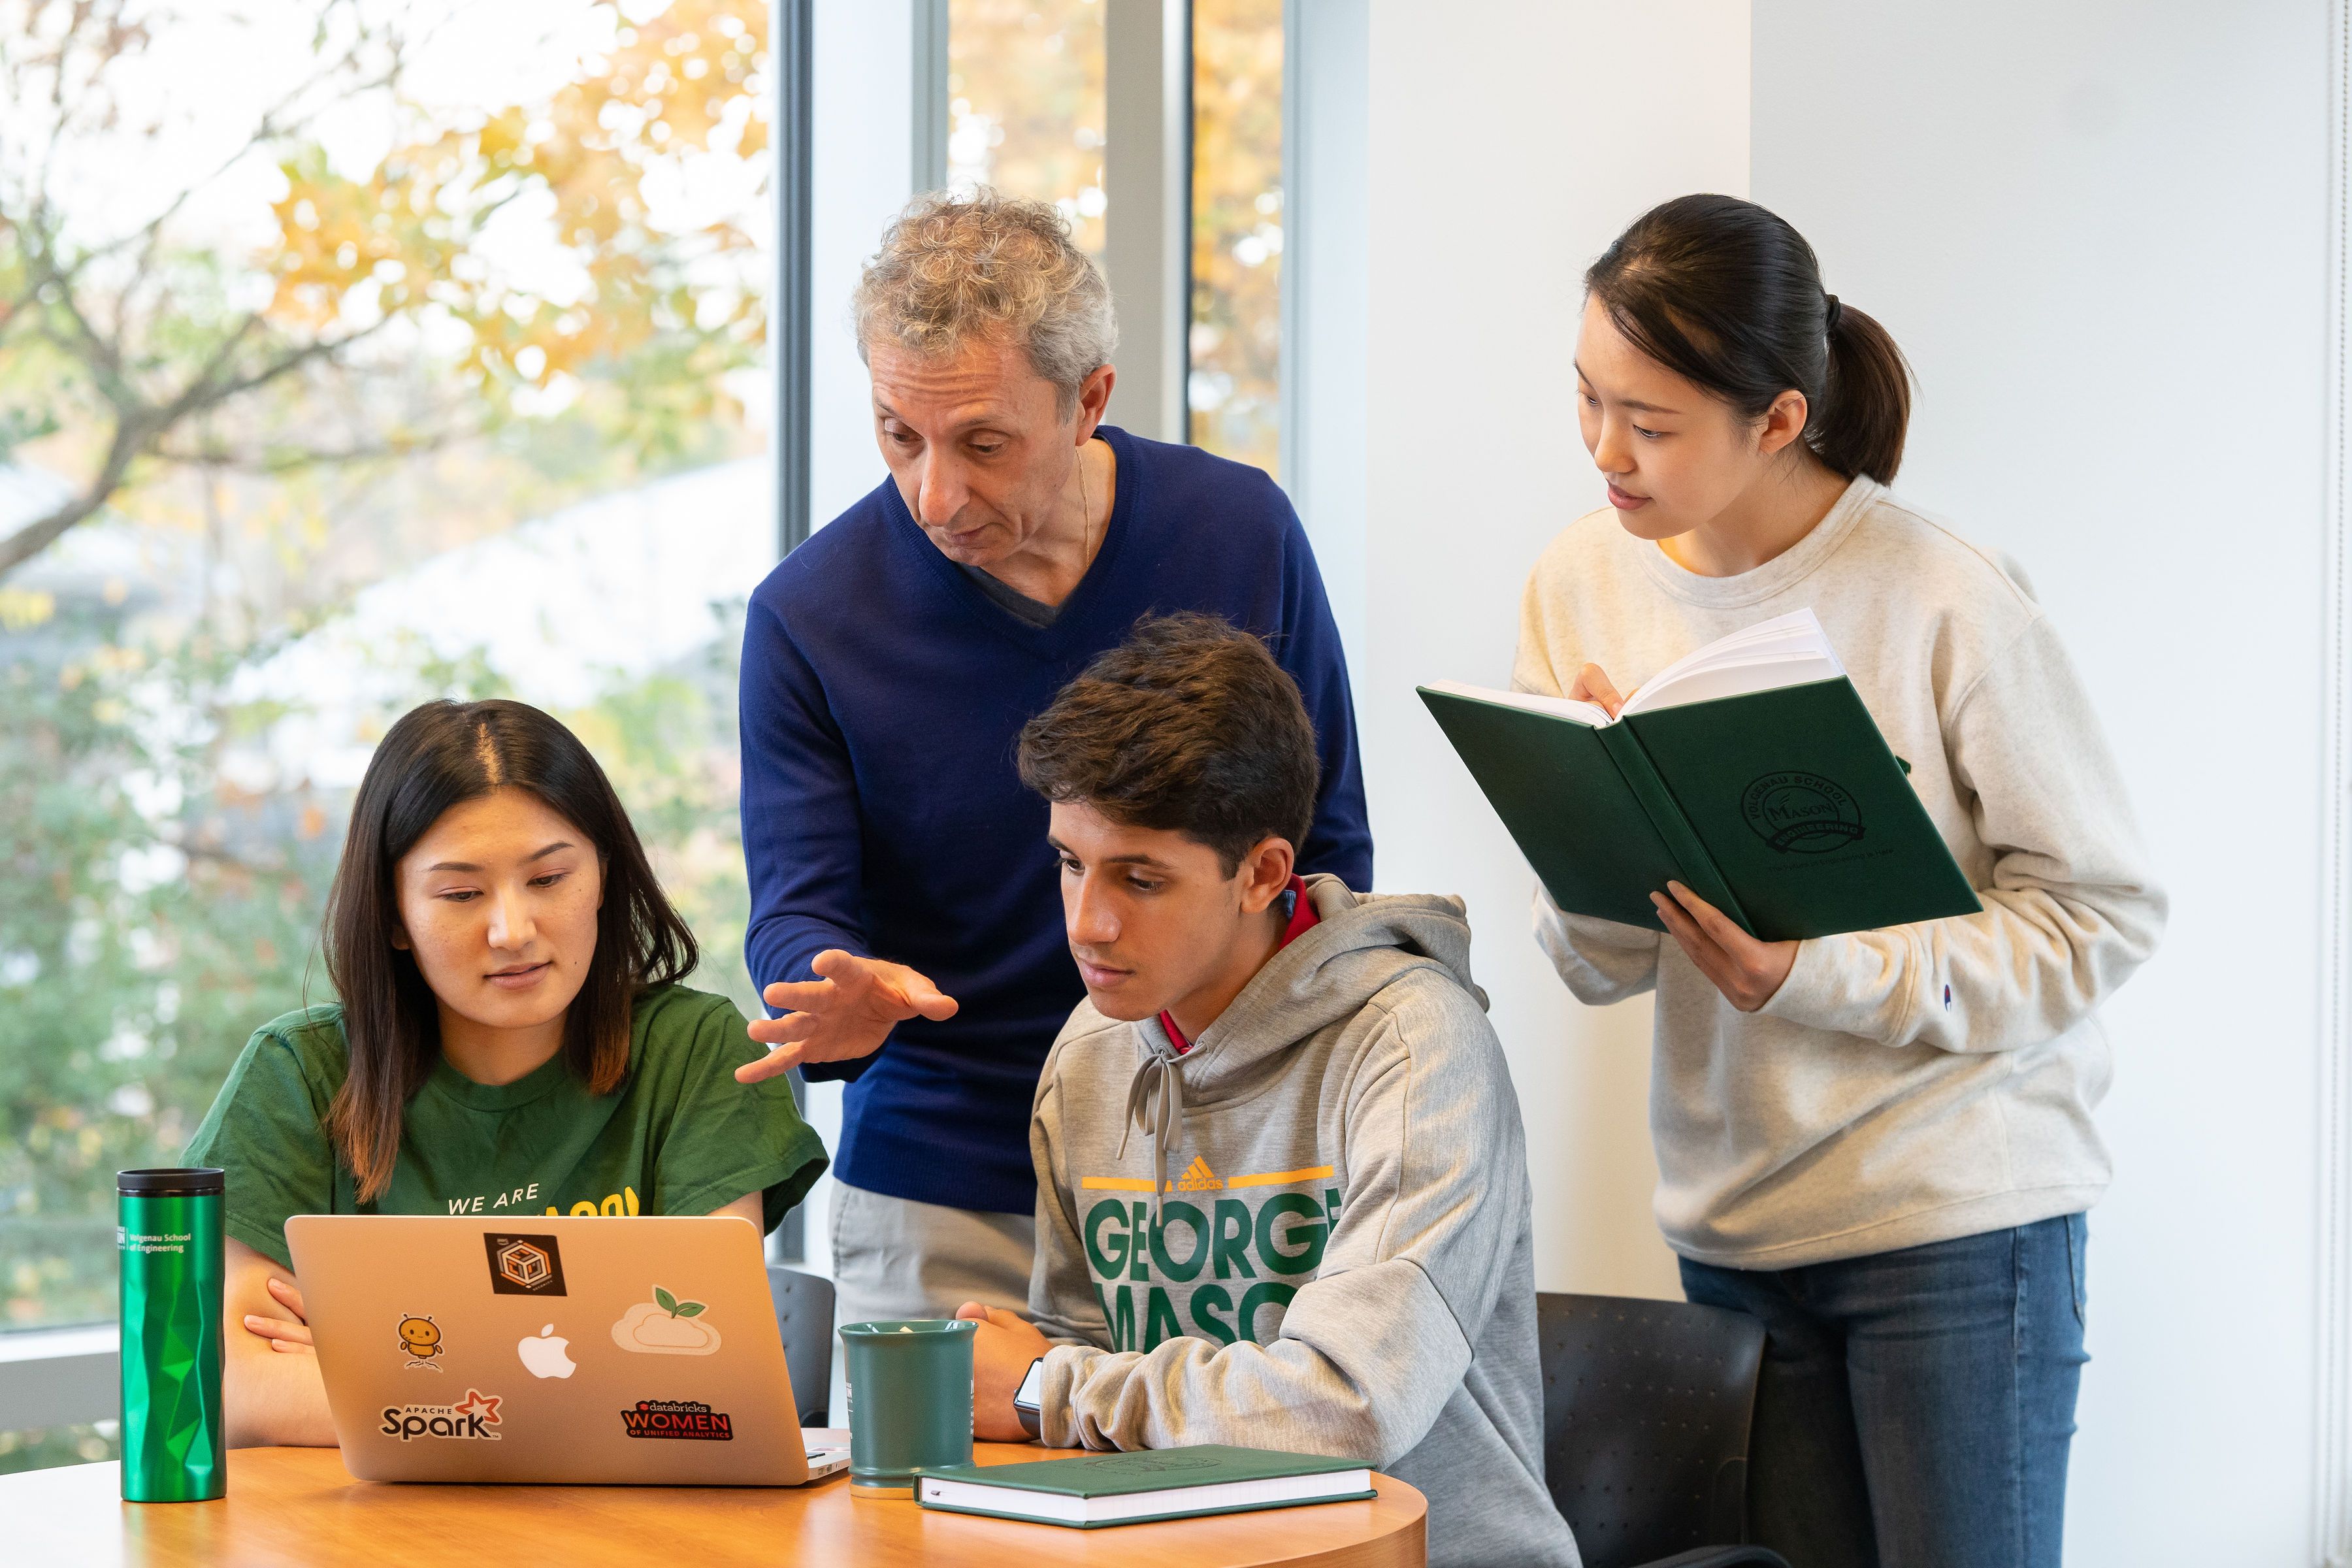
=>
[1755,0,2328,1565]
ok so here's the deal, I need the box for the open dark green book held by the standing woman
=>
[1420,609,1983,943]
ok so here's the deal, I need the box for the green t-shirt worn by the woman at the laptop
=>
[186,985,826,1267]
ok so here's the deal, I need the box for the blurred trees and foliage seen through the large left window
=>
[0,0,767,1354]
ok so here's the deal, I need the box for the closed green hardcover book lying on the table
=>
[915,1443,1373,1530]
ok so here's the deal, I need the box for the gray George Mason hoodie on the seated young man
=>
[1030,877,1578,1568]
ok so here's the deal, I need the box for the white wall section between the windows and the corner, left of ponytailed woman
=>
[1354,0,1748,1296]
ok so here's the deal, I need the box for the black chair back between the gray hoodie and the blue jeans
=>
[1536,1296,1788,1568]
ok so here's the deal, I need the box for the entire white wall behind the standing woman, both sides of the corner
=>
[1326,0,2328,1565]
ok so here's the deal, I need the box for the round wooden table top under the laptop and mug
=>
[0,1431,1426,1568]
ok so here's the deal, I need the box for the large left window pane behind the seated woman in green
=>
[0,0,774,1373]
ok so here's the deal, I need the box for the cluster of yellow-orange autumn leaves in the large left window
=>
[261,0,767,425]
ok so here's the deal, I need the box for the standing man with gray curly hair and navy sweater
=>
[738,190,1371,1354]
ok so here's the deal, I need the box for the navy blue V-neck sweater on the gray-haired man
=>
[743,425,1371,1213]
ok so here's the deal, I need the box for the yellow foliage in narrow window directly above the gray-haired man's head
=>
[948,0,1105,261]
